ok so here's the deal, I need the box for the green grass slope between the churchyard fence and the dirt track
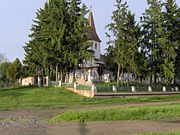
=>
[0,87,180,110]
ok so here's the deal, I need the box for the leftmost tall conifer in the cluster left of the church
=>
[24,3,49,75]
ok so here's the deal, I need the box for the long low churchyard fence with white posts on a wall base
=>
[46,81,180,97]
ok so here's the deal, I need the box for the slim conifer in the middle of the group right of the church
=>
[141,0,163,83]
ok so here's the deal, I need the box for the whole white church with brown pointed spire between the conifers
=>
[69,11,105,84]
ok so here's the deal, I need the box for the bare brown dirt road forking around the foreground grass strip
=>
[0,101,180,135]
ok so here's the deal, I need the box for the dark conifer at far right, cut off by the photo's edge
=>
[164,0,180,78]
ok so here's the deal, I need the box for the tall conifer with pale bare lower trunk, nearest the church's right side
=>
[107,0,138,85]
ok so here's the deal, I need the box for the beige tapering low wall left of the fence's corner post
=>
[67,88,95,98]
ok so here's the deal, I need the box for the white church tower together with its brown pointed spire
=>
[87,11,101,60]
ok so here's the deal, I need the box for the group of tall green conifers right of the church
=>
[106,0,180,84]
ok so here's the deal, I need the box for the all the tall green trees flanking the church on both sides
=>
[0,0,180,84]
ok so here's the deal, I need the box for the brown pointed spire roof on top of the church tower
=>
[87,11,101,42]
